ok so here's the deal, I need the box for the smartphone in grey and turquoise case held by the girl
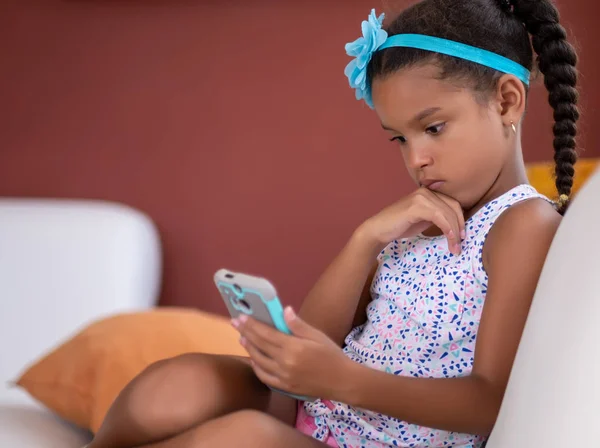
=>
[214,269,316,401]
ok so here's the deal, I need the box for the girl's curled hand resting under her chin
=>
[363,188,465,254]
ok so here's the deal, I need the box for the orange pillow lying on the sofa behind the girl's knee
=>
[17,308,247,432]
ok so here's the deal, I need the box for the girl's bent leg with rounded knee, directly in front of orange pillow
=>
[89,354,297,448]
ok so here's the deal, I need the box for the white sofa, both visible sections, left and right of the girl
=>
[0,172,600,448]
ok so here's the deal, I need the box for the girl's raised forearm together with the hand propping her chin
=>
[299,188,465,346]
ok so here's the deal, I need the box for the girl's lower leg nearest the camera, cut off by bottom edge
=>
[139,410,329,448]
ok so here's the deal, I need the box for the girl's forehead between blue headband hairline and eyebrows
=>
[371,64,477,123]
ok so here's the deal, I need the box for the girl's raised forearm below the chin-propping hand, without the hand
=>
[298,228,383,346]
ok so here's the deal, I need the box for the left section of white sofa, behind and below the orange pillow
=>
[0,198,162,448]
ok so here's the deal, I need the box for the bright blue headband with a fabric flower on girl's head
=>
[344,9,530,109]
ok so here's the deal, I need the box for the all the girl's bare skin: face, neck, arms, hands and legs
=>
[90,65,561,448]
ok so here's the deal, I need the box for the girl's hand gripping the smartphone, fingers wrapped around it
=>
[232,307,352,399]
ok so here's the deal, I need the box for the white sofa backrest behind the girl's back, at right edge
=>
[487,167,600,448]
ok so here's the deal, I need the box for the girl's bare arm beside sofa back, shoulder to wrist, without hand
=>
[336,200,560,435]
